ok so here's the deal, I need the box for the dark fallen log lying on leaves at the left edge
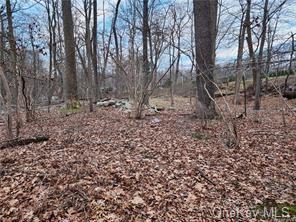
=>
[0,136,49,150]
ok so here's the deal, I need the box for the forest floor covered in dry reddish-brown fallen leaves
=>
[0,96,296,222]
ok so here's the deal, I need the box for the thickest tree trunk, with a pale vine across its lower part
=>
[193,0,218,119]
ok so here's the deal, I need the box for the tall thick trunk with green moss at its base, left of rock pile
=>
[62,0,78,108]
